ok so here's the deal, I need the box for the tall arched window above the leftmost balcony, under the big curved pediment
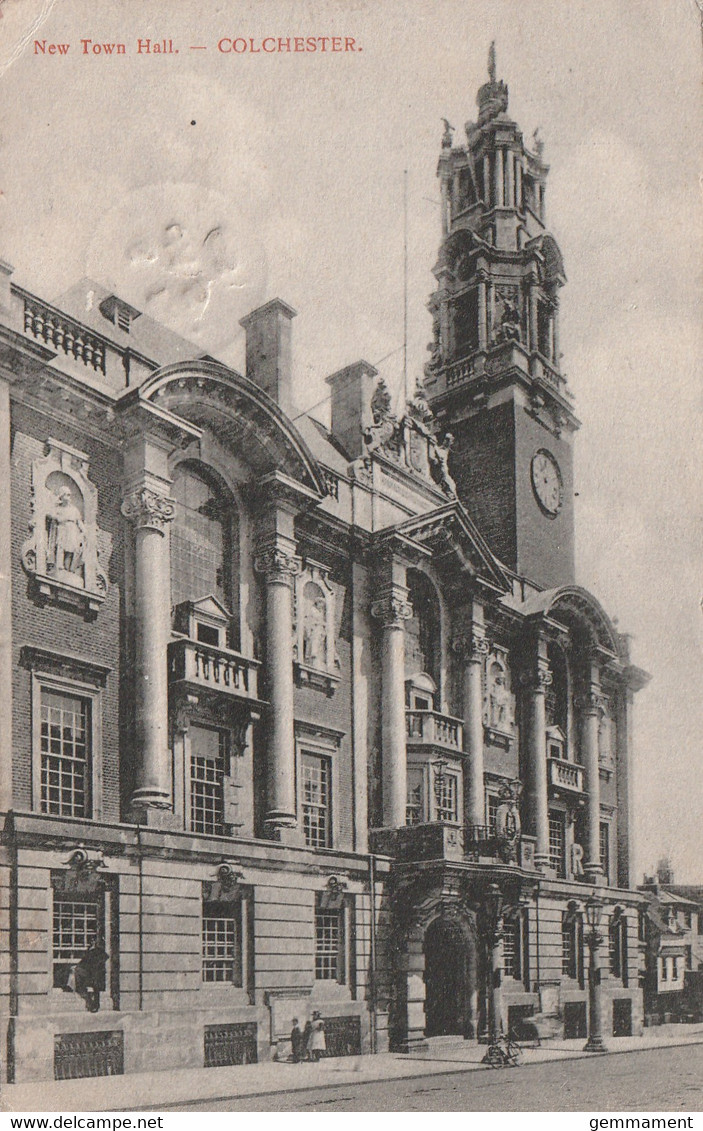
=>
[171,464,236,628]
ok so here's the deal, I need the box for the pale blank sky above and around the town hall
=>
[0,0,703,882]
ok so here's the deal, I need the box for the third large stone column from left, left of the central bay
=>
[371,579,413,829]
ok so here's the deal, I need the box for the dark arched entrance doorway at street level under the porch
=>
[423,918,476,1037]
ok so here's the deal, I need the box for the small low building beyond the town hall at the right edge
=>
[640,877,703,1024]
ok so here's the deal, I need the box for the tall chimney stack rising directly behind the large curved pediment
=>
[240,299,297,415]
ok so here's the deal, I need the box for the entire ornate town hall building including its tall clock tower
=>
[0,57,646,1081]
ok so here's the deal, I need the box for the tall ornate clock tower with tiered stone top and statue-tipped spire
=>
[425,44,579,588]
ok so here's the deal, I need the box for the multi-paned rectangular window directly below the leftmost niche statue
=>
[41,688,92,817]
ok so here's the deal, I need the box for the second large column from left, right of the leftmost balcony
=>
[254,532,301,843]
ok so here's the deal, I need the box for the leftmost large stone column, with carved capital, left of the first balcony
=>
[122,485,174,823]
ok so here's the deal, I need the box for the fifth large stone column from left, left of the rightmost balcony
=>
[526,640,552,869]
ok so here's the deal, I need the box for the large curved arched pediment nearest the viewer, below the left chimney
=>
[139,361,326,497]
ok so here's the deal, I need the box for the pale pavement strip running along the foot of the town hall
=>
[0,1025,703,1113]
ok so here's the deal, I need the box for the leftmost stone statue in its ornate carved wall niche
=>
[21,440,107,612]
